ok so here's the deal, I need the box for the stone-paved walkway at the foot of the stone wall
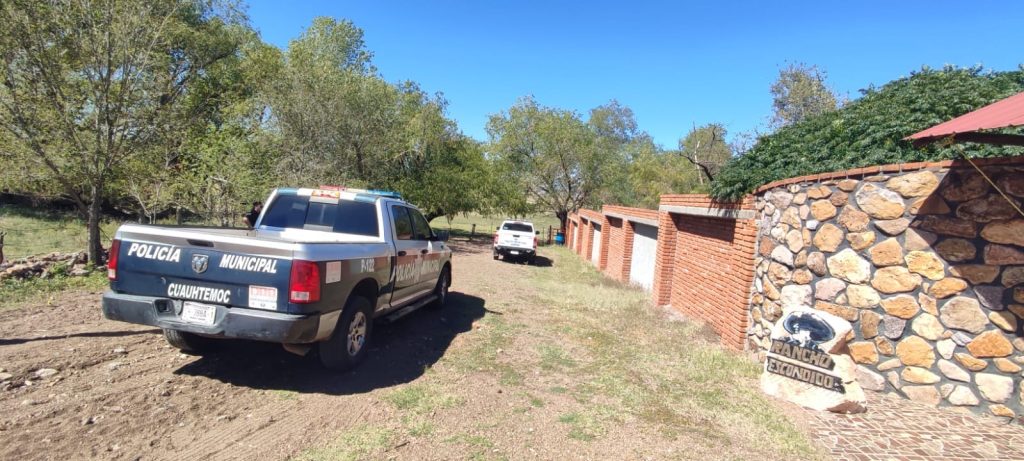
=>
[804,392,1024,461]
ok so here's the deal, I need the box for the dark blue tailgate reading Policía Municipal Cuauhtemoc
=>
[112,225,293,311]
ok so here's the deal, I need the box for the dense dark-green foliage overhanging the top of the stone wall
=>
[712,67,1024,199]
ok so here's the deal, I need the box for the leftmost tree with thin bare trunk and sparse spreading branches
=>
[0,0,244,264]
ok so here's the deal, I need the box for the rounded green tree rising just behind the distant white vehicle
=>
[486,97,607,228]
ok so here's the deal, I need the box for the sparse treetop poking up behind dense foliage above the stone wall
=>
[771,64,839,127]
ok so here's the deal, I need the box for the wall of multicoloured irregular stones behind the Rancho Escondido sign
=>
[746,158,1024,418]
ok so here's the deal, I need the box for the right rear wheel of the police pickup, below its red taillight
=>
[317,296,374,371]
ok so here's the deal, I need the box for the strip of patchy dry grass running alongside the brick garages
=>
[531,248,818,459]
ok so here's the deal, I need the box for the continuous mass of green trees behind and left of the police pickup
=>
[0,8,500,241]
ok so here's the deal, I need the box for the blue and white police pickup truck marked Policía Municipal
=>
[102,186,452,370]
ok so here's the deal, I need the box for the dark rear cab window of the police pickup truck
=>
[260,195,380,237]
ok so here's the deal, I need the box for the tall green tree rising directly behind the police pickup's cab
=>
[267,17,401,185]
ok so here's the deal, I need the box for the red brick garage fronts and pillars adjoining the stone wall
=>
[572,199,757,349]
